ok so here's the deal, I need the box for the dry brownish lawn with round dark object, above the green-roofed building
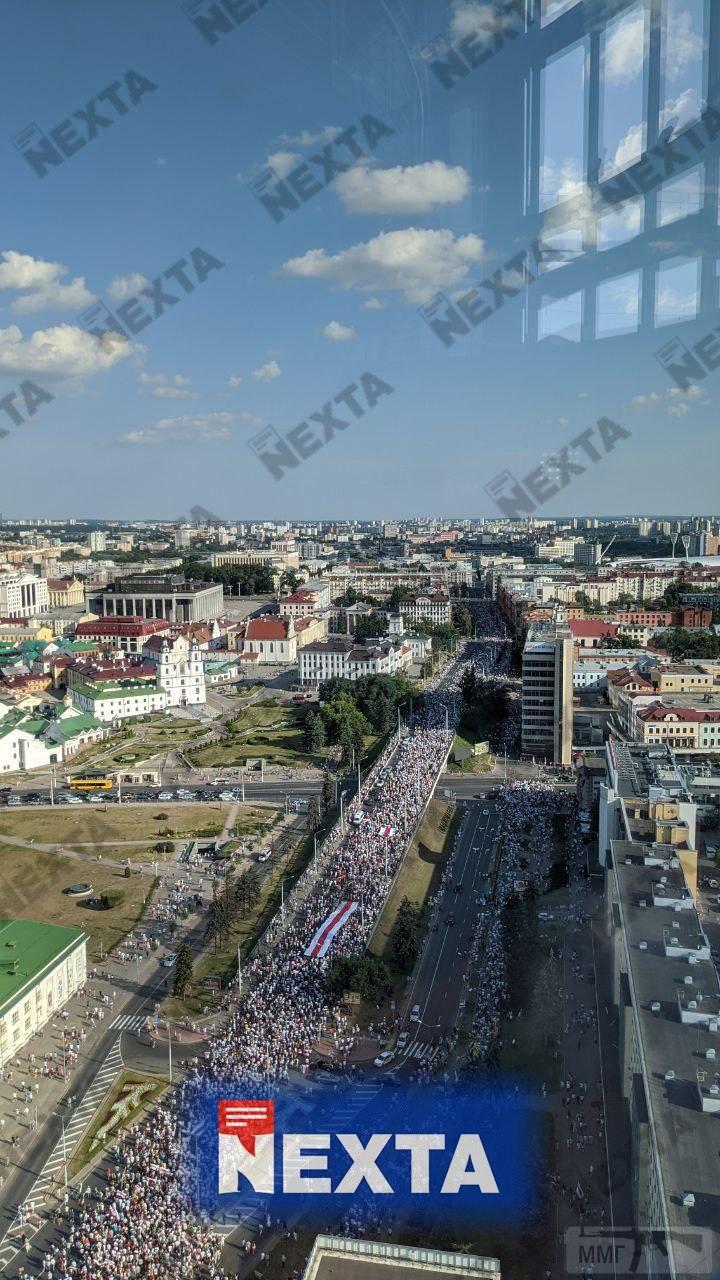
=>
[0,845,155,963]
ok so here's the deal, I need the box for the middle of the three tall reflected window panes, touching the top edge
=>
[600,4,647,178]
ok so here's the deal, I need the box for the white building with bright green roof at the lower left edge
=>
[0,920,87,1069]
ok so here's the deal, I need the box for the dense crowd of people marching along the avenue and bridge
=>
[26,609,543,1280]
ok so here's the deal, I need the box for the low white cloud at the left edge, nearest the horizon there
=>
[0,324,137,379]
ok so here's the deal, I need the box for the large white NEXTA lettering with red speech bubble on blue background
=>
[218,1098,500,1196]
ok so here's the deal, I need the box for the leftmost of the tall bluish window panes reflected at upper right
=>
[539,41,585,209]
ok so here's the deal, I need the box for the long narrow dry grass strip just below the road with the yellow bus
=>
[0,801,229,847]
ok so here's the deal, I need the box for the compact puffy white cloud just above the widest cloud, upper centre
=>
[334,160,470,214]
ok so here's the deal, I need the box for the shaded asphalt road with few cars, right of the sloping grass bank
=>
[387,800,500,1075]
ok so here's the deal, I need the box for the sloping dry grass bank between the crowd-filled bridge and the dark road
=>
[369,796,460,963]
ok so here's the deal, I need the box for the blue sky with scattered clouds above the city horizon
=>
[0,0,717,518]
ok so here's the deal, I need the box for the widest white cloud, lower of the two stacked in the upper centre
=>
[282,227,487,302]
